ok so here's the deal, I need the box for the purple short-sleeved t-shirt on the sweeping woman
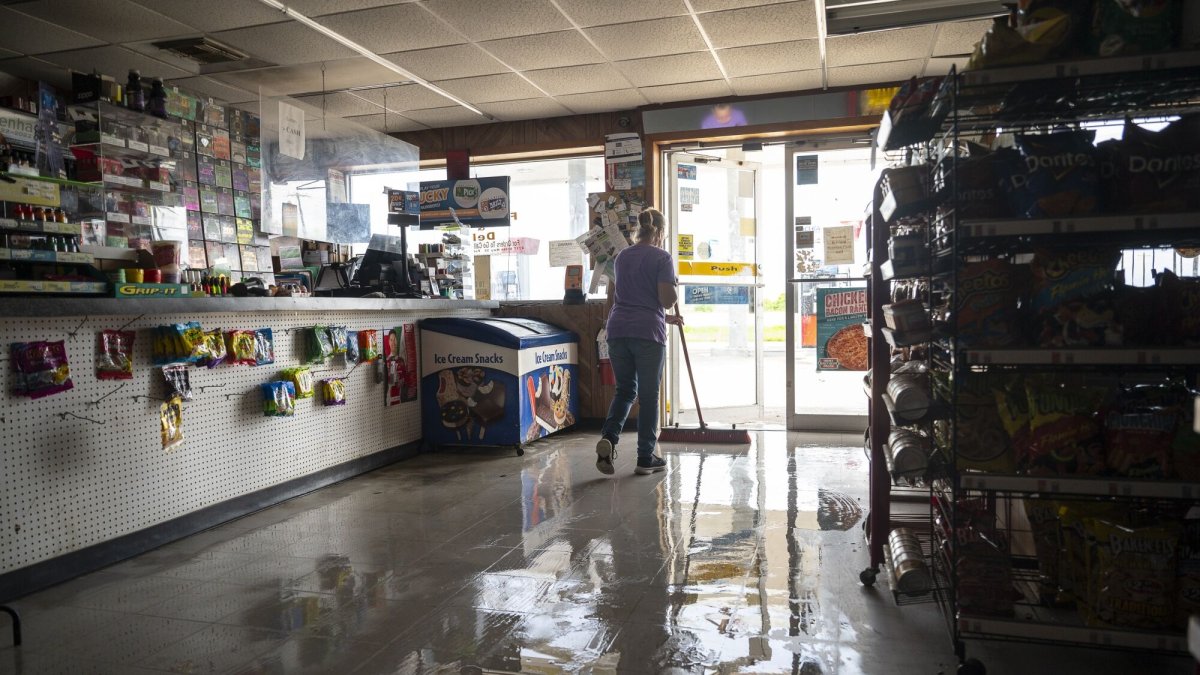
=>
[605,244,676,345]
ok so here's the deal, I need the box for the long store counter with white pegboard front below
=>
[0,298,498,603]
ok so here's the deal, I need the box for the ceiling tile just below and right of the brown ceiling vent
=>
[210,56,400,95]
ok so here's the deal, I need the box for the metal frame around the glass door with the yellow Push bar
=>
[660,148,763,424]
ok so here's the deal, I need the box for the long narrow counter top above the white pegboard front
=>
[0,298,500,318]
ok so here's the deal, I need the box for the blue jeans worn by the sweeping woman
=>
[600,338,667,460]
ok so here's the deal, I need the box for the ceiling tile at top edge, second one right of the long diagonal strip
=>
[425,0,571,41]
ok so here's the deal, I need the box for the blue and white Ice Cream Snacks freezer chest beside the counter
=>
[420,318,580,448]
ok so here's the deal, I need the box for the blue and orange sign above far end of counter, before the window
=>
[421,175,509,229]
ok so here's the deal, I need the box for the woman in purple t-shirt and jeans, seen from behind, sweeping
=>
[596,209,683,474]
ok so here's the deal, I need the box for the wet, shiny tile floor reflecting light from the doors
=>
[0,431,1192,675]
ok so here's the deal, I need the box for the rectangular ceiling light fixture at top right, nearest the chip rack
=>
[823,0,1008,35]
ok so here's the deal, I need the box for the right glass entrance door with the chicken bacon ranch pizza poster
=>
[781,138,877,432]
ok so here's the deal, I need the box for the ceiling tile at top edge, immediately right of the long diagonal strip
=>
[320,2,464,54]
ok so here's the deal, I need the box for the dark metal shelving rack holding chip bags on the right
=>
[860,52,1200,675]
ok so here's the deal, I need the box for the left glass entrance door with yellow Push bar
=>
[664,151,763,424]
